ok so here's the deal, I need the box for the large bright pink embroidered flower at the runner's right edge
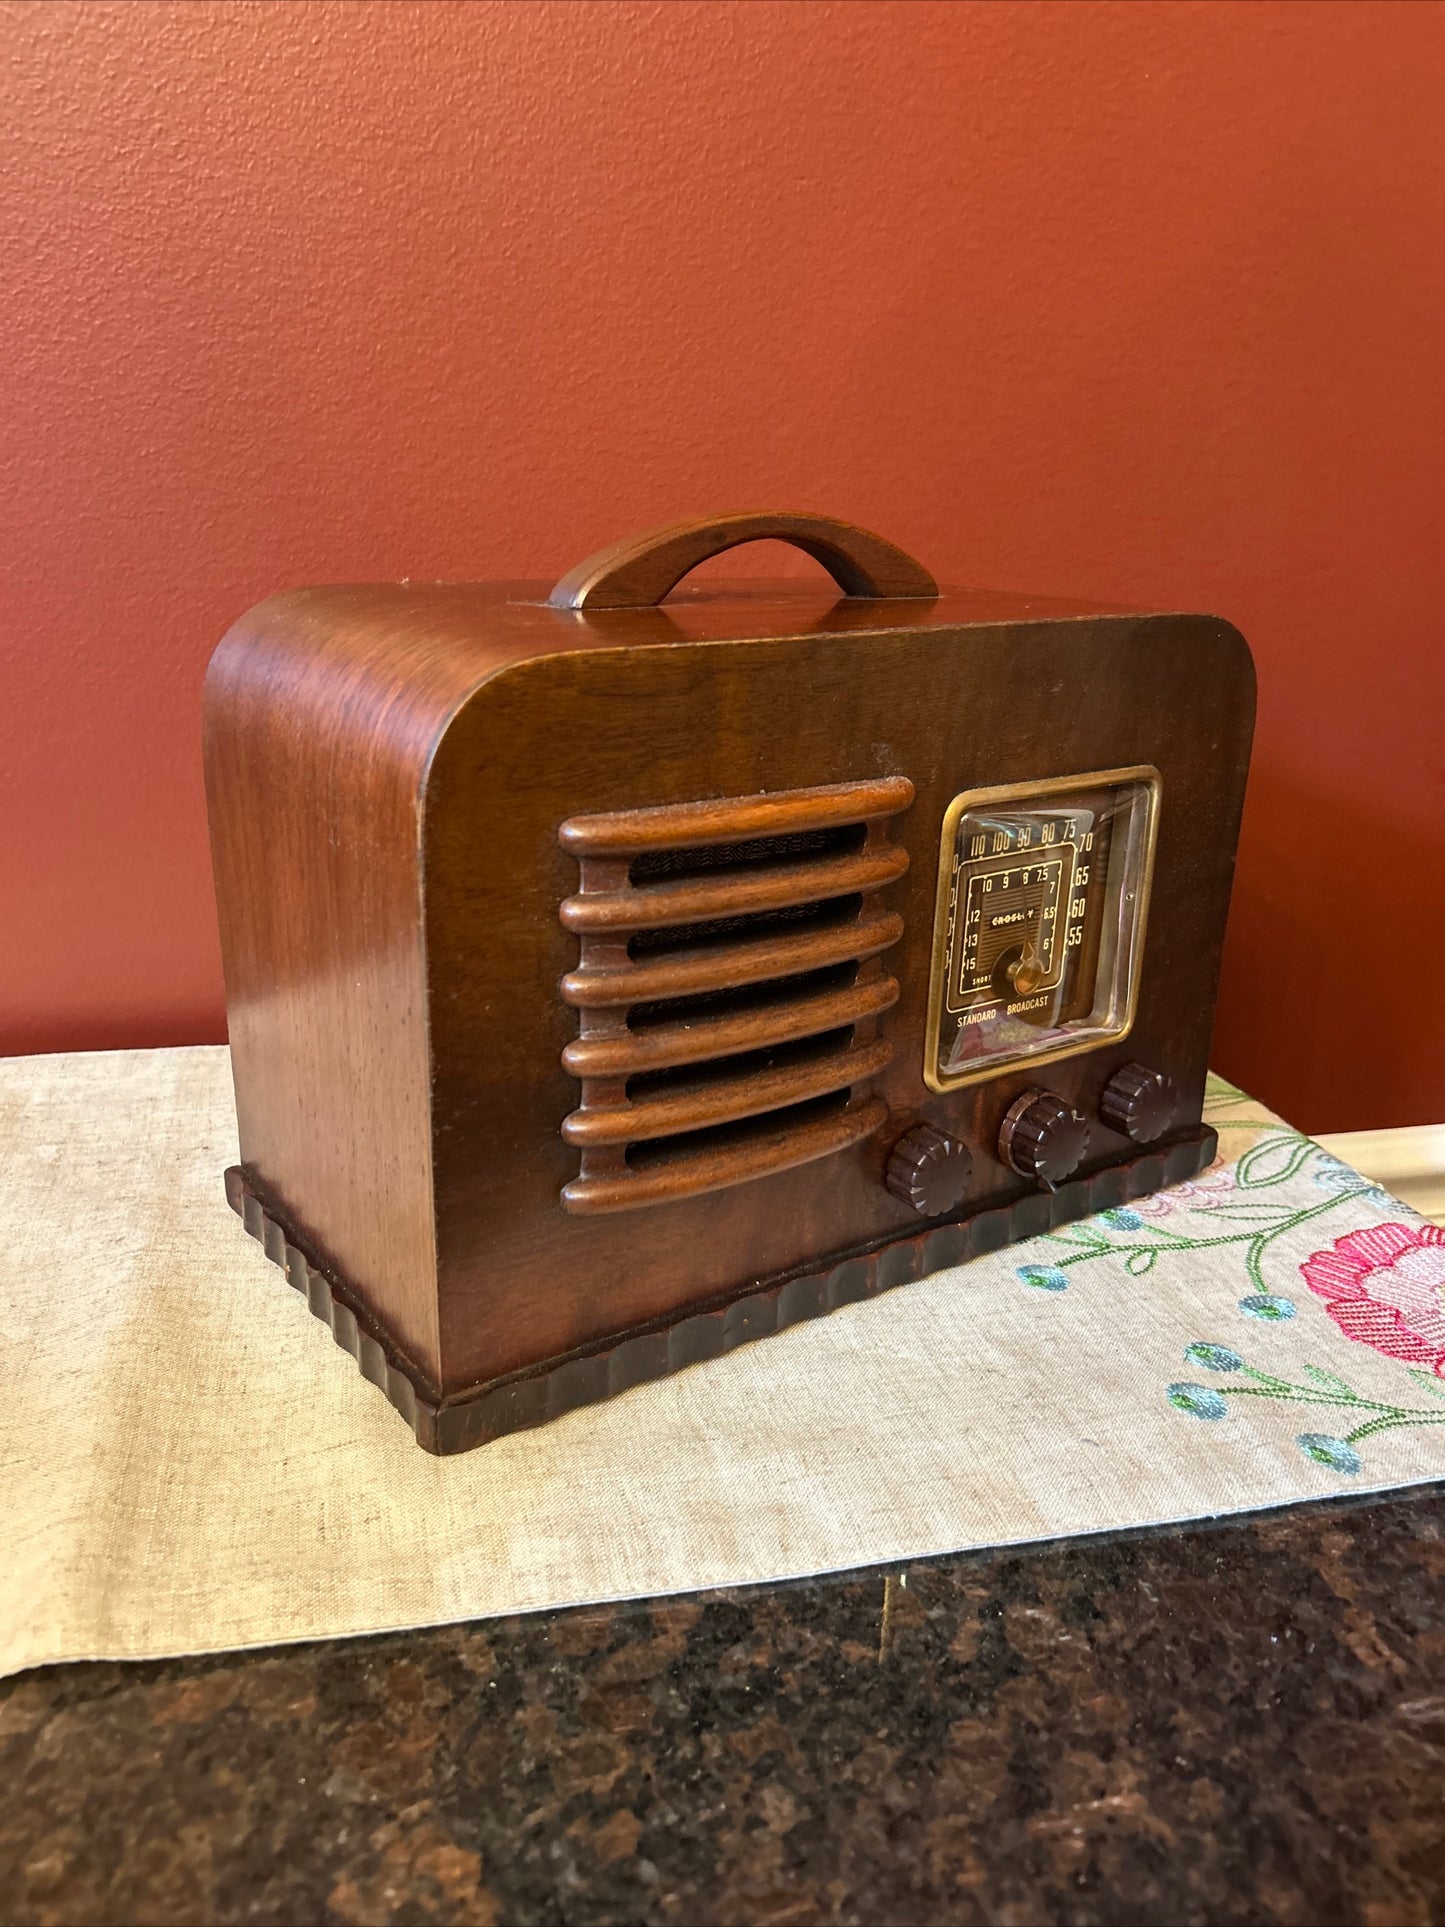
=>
[1301,1224,1445,1378]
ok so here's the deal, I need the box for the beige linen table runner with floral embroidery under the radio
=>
[0,1048,1445,1671]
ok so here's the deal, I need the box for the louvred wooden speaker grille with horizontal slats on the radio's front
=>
[559,777,913,1212]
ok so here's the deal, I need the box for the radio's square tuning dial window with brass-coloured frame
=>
[923,767,1160,1091]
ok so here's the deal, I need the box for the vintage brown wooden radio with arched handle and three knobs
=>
[206,515,1254,1453]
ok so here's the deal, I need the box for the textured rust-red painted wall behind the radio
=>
[0,0,1445,1129]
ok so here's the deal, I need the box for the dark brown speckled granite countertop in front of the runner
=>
[0,1486,1445,1927]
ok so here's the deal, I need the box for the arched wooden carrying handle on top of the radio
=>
[549,515,938,609]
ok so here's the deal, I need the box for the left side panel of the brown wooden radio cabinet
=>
[204,592,470,1386]
